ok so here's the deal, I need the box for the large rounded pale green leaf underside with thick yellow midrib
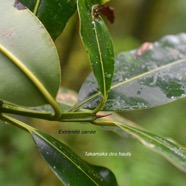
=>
[0,0,60,106]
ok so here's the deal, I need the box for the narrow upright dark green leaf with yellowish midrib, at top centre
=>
[78,0,114,99]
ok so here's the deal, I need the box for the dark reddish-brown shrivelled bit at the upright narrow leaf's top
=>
[93,5,115,23]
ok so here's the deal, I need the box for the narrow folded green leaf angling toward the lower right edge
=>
[116,120,186,172]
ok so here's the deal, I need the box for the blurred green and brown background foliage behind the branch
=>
[0,0,186,186]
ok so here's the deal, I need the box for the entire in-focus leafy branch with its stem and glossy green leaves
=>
[0,0,186,186]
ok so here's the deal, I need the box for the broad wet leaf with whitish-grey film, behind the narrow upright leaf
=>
[78,33,186,111]
